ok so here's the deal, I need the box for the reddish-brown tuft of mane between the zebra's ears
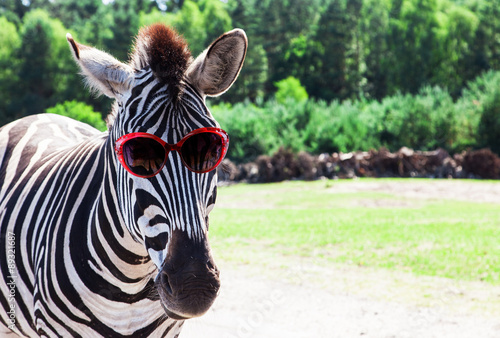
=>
[130,23,192,97]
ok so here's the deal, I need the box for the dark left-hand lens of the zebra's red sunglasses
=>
[122,137,165,177]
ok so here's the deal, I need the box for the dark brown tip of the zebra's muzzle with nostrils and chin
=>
[155,256,220,320]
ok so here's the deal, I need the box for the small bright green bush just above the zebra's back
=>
[45,101,107,131]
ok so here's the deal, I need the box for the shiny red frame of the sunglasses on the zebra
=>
[115,127,229,178]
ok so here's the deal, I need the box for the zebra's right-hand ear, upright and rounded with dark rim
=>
[186,29,248,96]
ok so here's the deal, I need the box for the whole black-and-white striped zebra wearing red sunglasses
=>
[0,24,248,337]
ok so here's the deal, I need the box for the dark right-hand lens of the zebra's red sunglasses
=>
[181,133,224,172]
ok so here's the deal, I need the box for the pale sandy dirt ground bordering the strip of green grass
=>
[180,180,500,338]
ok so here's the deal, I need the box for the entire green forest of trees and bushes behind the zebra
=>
[0,0,500,162]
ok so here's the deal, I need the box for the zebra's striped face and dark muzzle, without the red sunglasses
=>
[115,82,220,319]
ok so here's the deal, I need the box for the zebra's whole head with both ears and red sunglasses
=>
[67,24,247,319]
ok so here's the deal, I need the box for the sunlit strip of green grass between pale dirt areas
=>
[210,180,500,284]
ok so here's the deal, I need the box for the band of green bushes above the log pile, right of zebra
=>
[212,72,500,163]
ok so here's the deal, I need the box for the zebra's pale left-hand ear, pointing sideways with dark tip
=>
[66,33,134,99]
